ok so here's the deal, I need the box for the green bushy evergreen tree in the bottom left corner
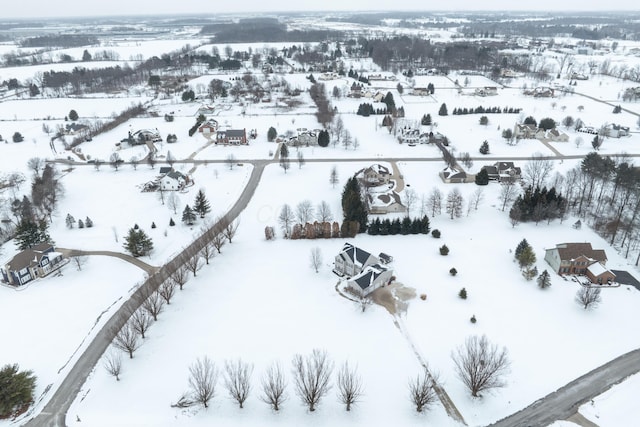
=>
[0,364,36,419]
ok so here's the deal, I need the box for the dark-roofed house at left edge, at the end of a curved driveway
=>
[0,243,69,286]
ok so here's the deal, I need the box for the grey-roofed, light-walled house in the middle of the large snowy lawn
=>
[333,243,393,297]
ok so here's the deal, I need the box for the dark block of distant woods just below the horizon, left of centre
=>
[201,18,343,43]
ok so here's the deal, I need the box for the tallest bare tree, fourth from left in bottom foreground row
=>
[293,349,333,412]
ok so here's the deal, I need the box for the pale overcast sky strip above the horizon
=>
[0,0,633,19]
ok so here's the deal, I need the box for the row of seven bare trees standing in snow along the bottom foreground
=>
[172,336,510,412]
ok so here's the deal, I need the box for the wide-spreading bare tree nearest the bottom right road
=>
[451,335,510,397]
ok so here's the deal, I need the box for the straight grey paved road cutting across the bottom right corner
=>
[489,349,640,427]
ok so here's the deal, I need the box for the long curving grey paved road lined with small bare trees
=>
[25,163,265,427]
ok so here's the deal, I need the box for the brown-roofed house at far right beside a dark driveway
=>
[544,243,616,283]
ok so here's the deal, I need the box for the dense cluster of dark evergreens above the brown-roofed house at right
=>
[509,186,567,224]
